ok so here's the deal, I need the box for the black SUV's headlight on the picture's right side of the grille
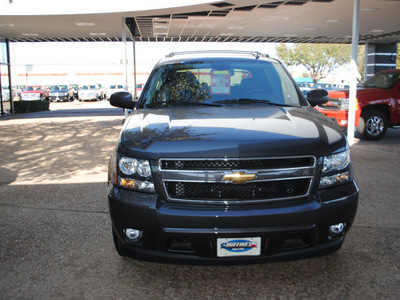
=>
[319,150,351,188]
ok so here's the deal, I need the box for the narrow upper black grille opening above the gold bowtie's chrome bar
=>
[160,157,314,170]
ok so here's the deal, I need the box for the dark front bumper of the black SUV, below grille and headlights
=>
[108,182,358,263]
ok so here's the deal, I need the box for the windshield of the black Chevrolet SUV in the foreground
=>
[141,60,302,108]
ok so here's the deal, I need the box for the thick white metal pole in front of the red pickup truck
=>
[347,0,360,146]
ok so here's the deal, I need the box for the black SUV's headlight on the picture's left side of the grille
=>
[117,156,155,193]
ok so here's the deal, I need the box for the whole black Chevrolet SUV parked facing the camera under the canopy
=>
[108,51,358,263]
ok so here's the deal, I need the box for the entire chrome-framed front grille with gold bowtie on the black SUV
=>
[159,156,316,204]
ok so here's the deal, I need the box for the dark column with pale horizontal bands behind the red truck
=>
[365,43,397,79]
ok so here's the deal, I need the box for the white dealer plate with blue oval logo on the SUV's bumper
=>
[217,237,261,257]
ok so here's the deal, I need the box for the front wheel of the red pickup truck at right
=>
[357,109,388,140]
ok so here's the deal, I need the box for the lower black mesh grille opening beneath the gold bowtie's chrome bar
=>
[165,178,310,201]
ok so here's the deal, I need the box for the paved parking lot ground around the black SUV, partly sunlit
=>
[0,101,400,299]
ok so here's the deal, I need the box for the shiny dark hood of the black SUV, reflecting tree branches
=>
[118,105,346,159]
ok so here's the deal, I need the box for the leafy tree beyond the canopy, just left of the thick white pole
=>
[276,44,351,83]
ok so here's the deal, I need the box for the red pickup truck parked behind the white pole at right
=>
[315,69,400,140]
